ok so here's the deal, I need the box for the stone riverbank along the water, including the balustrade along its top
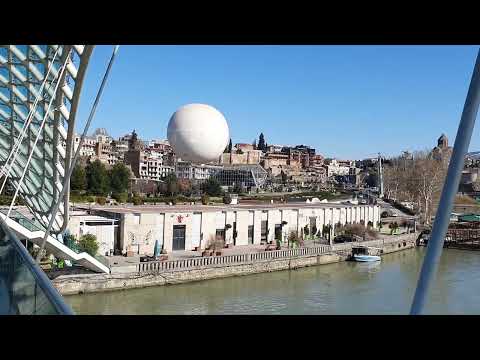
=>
[52,234,417,295]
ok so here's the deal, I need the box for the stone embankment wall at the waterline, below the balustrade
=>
[53,234,416,295]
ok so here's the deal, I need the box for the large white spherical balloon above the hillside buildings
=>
[167,104,230,163]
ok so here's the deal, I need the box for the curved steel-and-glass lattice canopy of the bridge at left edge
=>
[0,45,93,235]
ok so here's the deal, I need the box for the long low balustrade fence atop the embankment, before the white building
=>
[137,245,331,272]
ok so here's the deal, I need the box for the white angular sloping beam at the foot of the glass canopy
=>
[0,210,110,274]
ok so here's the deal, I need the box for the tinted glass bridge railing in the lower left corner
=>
[0,218,73,315]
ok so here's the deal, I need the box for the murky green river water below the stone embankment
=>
[65,248,480,315]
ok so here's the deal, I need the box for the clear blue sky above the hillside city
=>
[77,45,480,159]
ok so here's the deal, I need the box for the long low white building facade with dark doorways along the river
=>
[85,203,380,255]
